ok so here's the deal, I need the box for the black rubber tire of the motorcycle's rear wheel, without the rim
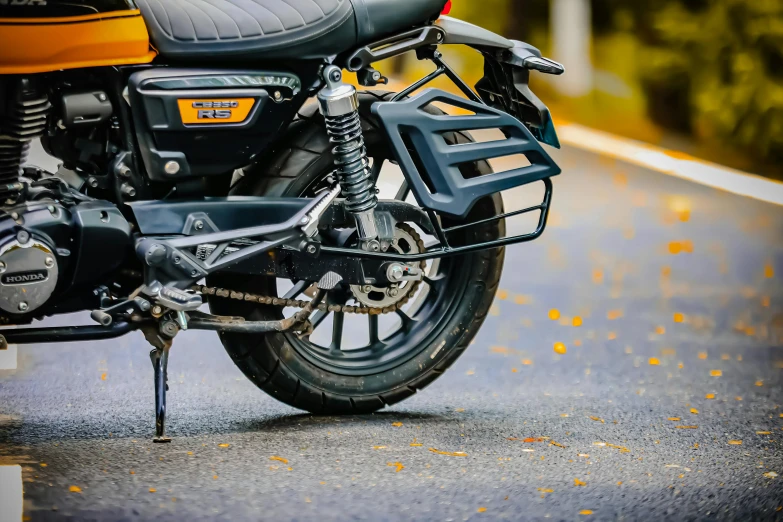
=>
[208,93,505,414]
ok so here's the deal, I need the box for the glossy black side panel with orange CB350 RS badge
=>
[129,67,306,182]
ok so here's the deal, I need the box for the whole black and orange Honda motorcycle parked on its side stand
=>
[0,0,564,442]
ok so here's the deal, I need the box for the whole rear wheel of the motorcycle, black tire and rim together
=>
[208,93,505,414]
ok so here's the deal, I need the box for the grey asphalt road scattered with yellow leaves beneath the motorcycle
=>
[0,140,783,521]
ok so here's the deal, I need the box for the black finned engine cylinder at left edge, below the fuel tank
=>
[0,78,51,197]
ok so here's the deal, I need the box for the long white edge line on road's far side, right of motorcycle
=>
[557,123,783,205]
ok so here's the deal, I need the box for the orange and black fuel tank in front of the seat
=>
[0,0,157,74]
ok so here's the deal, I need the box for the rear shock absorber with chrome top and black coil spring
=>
[318,65,380,252]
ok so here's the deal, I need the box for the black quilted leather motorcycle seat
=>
[137,0,446,60]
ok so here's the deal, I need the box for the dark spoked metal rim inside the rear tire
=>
[278,154,478,375]
